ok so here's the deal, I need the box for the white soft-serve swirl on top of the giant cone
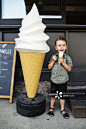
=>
[15,3,50,53]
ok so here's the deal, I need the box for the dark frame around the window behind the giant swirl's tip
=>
[0,0,66,25]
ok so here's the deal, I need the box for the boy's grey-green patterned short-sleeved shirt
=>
[49,53,73,84]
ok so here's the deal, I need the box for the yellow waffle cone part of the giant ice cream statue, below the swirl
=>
[19,52,45,98]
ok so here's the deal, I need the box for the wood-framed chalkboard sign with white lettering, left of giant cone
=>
[0,42,16,103]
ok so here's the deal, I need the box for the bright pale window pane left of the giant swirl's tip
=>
[1,0,26,19]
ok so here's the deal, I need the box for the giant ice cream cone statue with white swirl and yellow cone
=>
[15,4,50,98]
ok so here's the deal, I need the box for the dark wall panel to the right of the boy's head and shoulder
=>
[68,32,86,68]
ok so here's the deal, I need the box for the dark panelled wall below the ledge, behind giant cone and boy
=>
[0,30,86,85]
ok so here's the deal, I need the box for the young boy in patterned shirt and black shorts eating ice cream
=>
[48,36,73,119]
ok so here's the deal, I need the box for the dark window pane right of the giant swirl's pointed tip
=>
[25,0,62,18]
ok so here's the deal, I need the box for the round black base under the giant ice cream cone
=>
[16,93,46,117]
